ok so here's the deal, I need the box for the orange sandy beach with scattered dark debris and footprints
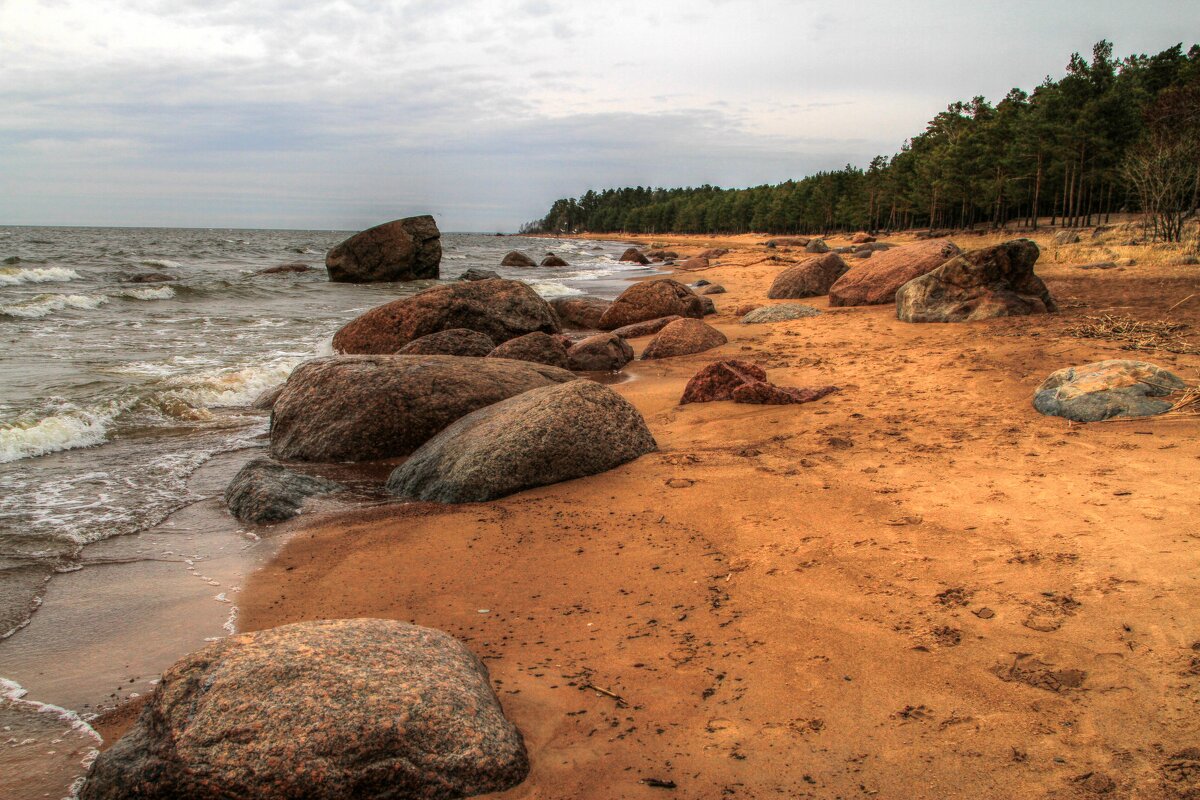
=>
[124,227,1200,798]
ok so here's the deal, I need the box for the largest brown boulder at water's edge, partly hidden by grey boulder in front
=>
[271,355,575,462]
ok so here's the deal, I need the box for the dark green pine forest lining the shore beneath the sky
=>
[522,41,1200,241]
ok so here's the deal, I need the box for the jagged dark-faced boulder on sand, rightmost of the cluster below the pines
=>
[896,239,1057,323]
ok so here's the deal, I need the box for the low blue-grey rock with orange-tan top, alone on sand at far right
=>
[1033,359,1187,422]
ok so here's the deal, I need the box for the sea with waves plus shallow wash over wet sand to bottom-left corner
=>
[0,227,652,798]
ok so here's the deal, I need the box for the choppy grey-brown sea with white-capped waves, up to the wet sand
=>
[0,228,643,638]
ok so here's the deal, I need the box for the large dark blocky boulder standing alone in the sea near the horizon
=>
[325,215,442,283]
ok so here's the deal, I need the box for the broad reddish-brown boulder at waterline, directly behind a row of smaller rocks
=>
[334,278,558,354]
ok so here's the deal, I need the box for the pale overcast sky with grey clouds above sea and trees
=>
[0,0,1200,231]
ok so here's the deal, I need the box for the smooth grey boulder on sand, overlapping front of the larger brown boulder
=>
[388,380,658,503]
